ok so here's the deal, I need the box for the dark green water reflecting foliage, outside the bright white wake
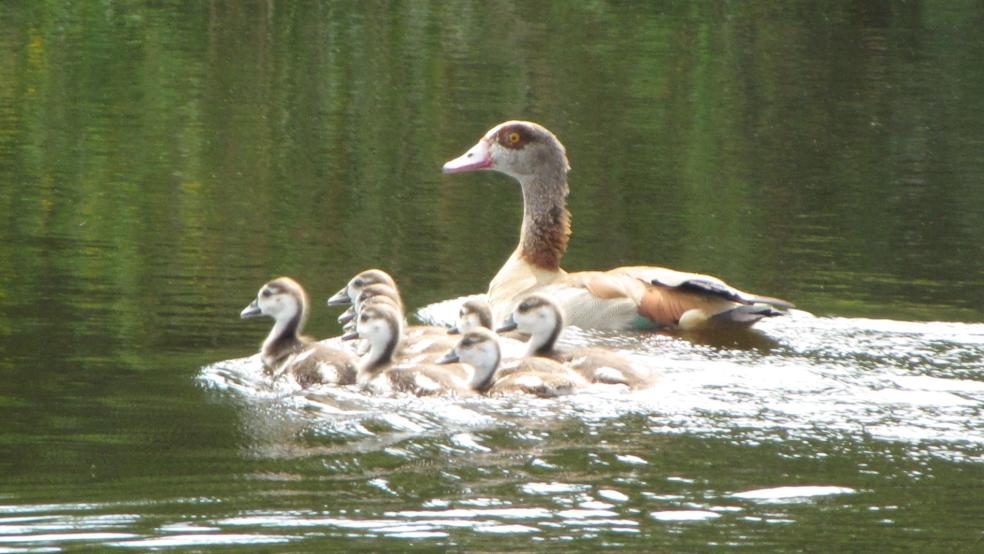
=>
[0,2,984,549]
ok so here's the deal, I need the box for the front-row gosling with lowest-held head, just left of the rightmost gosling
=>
[437,327,588,397]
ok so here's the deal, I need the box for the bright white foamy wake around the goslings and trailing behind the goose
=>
[200,297,984,464]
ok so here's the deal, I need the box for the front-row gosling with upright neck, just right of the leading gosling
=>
[350,303,491,396]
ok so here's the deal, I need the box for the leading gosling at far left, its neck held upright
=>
[239,277,358,387]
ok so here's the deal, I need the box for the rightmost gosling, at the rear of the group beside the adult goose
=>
[497,294,655,389]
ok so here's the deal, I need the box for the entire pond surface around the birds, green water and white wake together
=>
[0,2,984,552]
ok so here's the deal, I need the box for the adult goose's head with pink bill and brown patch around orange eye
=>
[443,121,570,182]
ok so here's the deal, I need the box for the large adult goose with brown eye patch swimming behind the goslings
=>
[444,121,792,330]
